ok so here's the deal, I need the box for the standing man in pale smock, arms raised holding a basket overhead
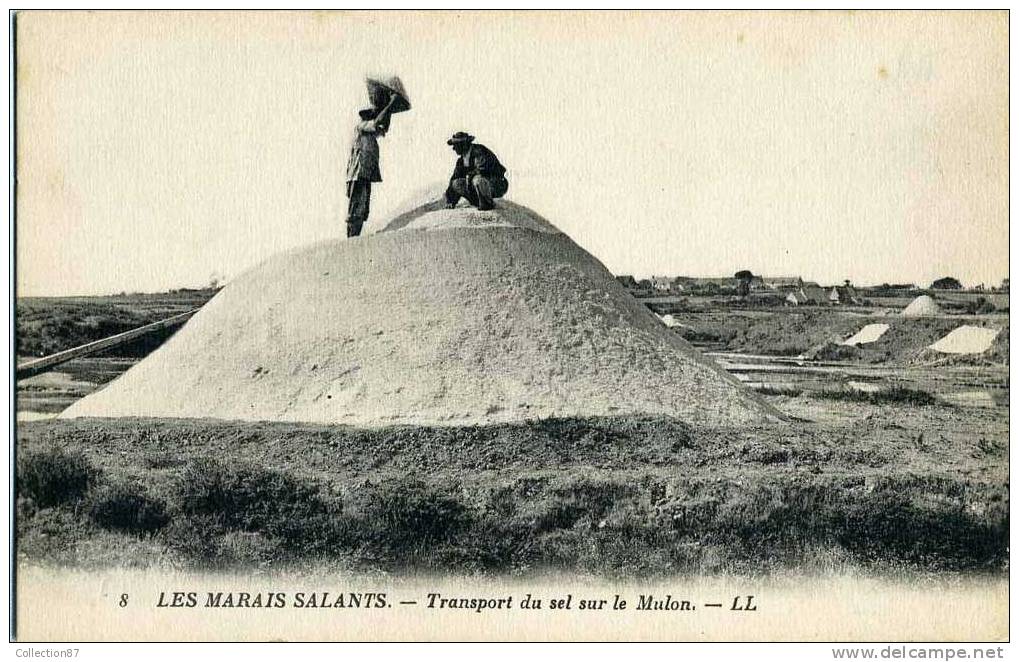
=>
[346,94,397,236]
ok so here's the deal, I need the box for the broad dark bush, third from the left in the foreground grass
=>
[173,461,327,535]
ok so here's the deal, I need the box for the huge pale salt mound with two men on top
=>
[62,201,777,426]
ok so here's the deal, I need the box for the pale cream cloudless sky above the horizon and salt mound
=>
[17,11,1008,295]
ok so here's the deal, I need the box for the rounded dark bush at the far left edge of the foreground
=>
[16,446,99,508]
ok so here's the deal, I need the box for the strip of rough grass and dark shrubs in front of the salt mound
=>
[17,405,1009,576]
